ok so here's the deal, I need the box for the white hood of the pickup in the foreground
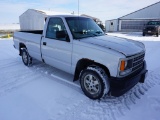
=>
[80,35,145,56]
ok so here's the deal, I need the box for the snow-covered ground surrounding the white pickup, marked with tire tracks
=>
[0,33,160,120]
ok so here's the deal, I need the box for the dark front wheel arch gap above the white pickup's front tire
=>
[74,58,110,81]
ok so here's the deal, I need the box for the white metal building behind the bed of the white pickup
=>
[19,9,71,30]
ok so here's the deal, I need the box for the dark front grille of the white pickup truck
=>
[132,53,145,72]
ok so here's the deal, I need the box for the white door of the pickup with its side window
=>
[41,17,72,72]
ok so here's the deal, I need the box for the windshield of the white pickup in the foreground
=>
[66,17,105,39]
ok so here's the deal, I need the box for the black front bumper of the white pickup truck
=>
[110,61,148,97]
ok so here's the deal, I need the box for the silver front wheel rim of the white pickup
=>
[84,74,101,95]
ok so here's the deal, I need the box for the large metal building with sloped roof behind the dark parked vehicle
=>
[105,1,160,32]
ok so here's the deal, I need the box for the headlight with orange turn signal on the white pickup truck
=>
[119,59,133,76]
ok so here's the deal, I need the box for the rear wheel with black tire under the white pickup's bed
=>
[21,48,32,66]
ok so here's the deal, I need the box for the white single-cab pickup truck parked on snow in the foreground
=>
[13,15,147,99]
